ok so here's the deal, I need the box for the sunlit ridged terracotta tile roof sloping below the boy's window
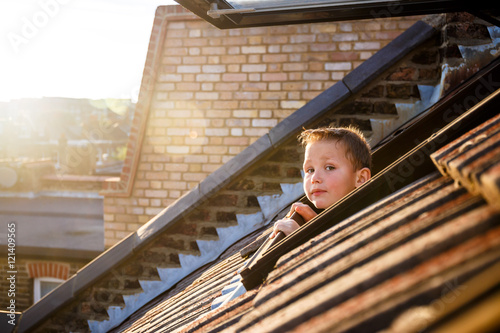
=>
[112,91,500,332]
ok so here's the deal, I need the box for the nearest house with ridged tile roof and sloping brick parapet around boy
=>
[8,1,500,332]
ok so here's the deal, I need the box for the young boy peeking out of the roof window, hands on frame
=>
[269,127,371,238]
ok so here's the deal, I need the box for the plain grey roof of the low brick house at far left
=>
[0,195,104,259]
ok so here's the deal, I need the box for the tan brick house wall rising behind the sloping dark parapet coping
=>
[103,6,426,247]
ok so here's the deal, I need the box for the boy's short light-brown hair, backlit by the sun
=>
[298,126,372,170]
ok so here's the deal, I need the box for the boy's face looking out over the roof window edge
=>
[304,140,357,208]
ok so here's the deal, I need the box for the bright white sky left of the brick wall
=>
[0,0,176,102]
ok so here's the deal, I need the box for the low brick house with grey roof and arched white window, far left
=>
[0,191,104,332]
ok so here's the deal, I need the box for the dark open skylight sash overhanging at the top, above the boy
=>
[176,0,492,29]
